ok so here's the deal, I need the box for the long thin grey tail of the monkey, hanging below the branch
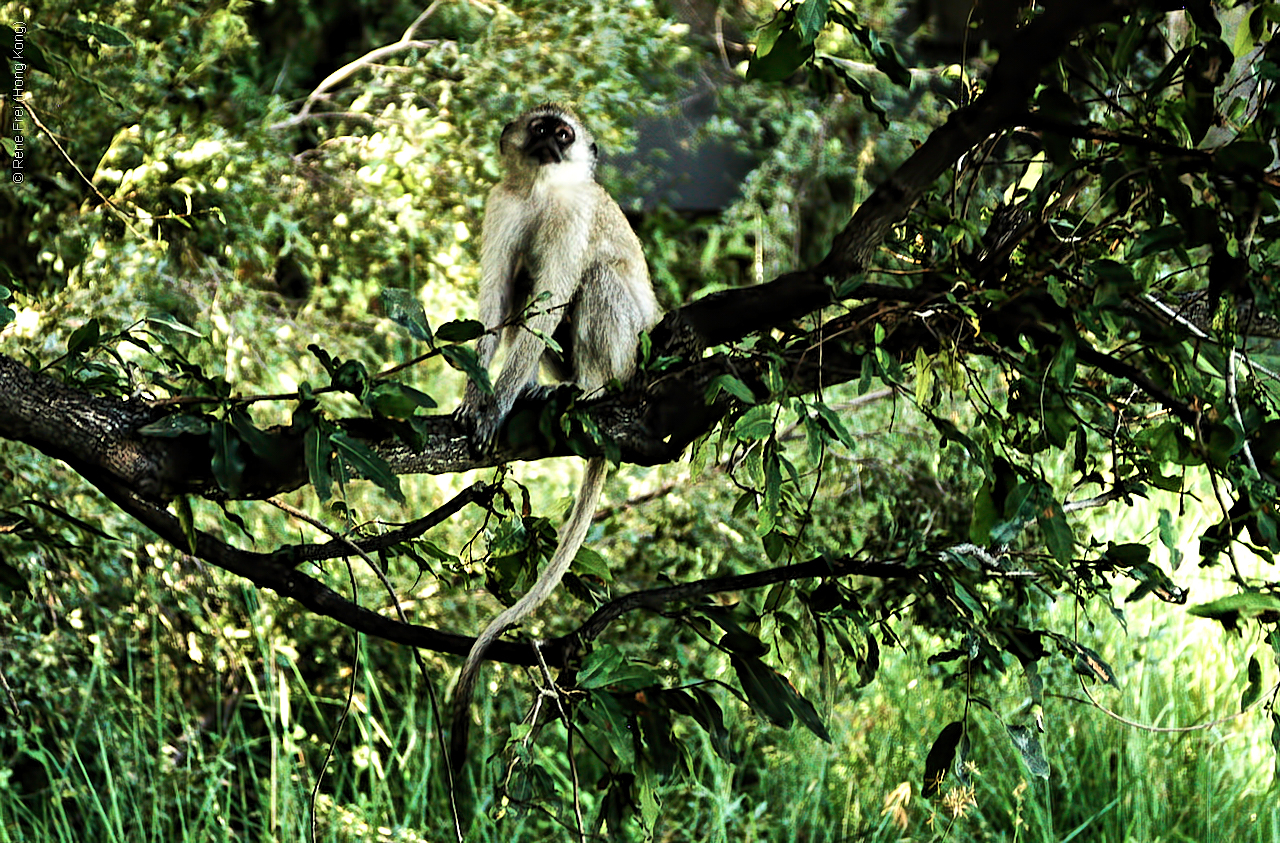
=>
[449,457,609,773]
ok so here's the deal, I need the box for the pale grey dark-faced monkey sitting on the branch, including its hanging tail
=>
[451,102,660,768]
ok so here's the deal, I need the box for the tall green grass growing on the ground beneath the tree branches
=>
[0,567,1280,843]
